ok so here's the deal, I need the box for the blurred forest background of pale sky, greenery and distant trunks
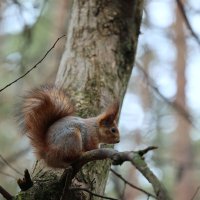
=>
[0,0,200,200]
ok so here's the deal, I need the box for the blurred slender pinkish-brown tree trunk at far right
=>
[174,1,195,200]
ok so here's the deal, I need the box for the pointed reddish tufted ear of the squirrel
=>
[99,100,119,126]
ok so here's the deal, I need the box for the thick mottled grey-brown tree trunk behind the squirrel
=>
[15,0,143,200]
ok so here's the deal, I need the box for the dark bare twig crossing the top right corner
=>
[176,0,200,45]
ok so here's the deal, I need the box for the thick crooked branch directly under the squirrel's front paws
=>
[71,147,171,200]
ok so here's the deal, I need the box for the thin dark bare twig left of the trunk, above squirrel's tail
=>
[0,35,65,92]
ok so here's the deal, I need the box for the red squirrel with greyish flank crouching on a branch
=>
[21,86,120,168]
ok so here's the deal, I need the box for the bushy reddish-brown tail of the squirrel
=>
[20,85,74,154]
